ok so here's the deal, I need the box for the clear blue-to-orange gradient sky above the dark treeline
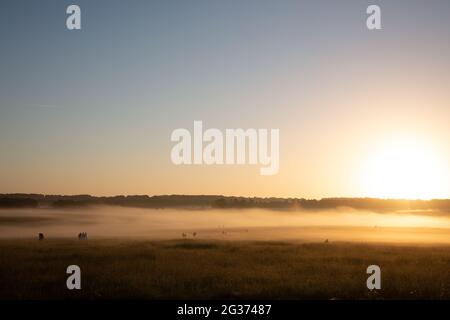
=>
[0,0,450,198]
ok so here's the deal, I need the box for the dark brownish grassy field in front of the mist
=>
[0,239,450,299]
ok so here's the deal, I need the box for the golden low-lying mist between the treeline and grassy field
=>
[0,206,450,244]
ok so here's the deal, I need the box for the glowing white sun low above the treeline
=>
[361,138,448,199]
